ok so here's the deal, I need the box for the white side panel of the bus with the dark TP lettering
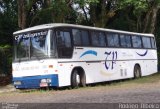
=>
[58,47,157,86]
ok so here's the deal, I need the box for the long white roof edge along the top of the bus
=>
[13,23,154,37]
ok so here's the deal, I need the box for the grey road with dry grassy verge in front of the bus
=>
[0,81,160,108]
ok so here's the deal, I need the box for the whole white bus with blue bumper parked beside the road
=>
[12,23,157,89]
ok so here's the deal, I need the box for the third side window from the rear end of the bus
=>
[132,36,142,48]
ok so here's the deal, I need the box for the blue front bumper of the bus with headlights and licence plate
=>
[13,74,59,89]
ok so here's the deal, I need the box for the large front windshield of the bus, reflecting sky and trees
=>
[15,30,55,61]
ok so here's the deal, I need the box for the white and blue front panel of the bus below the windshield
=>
[12,59,59,88]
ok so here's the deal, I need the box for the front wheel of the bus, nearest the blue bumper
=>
[71,69,86,88]
